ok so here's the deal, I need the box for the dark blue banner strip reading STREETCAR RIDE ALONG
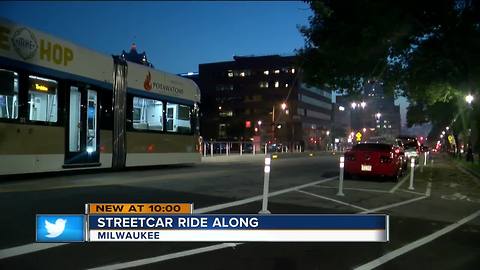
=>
[88,215,387,230]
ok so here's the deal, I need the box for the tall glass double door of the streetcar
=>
[65,86,100,167]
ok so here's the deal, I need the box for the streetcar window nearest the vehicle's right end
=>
[167,102,192,134]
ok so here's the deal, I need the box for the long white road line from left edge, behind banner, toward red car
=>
[0,176,338,259]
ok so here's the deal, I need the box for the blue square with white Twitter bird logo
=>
[35,214,86,243]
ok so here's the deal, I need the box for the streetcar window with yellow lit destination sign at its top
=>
[28,76,58,122]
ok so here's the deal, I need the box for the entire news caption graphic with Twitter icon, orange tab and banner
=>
[37,203,389,242]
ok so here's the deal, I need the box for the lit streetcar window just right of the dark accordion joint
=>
[133,97,163,131]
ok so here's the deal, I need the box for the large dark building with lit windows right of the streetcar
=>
[198,55,332,148]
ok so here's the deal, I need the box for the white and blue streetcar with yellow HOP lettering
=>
[0,18,200,175]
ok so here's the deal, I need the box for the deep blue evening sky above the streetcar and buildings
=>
[0,1,312,73]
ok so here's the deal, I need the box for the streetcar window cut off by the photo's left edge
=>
[0,69,18,119]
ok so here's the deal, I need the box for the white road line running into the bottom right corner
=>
[355,210,480,270]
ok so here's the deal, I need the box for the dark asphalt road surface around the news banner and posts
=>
[0,156,480,270]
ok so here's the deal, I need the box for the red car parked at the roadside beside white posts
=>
[345,142,405,181]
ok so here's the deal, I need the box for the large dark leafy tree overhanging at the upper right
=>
[298,0,480,148]
